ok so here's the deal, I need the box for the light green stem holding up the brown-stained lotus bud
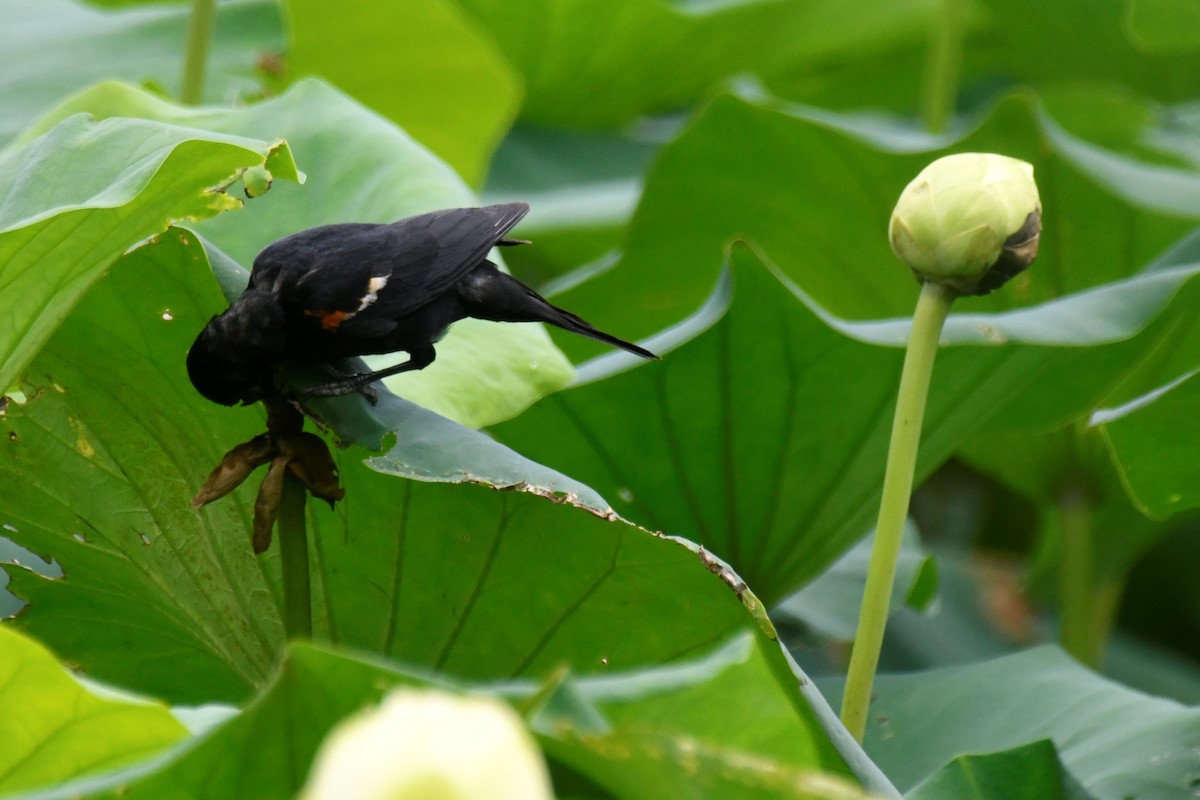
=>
[841,283,955,741]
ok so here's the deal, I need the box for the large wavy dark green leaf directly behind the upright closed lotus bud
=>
[558,94,1200,362]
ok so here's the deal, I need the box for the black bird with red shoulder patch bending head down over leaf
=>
[187,203,658,405]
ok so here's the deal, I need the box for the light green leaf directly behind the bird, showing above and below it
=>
[27,79,571,426]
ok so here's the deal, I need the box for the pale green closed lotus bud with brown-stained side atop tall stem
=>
[888,152,1042,295]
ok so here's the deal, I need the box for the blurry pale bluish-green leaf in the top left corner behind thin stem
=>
[0,0,283,145]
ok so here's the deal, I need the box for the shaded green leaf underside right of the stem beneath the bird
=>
[312,465,761,678]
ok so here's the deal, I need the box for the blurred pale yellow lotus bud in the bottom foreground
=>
[300,688,553,800]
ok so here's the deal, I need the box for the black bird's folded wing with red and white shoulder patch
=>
[251,203,529,336]
